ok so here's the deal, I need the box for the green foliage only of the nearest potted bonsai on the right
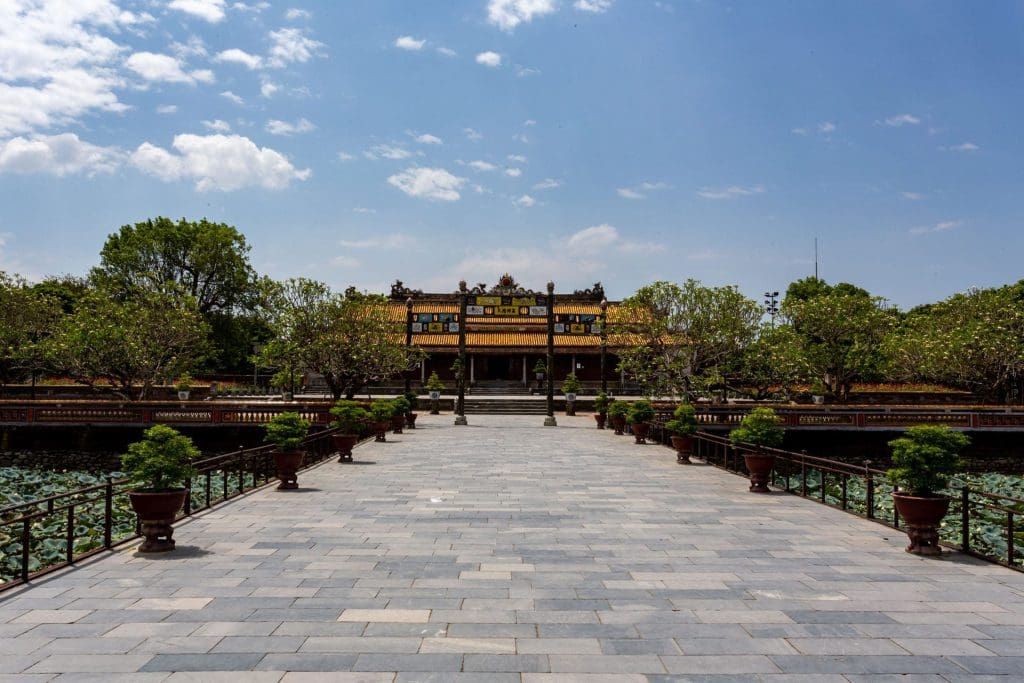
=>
[886,425,971,497]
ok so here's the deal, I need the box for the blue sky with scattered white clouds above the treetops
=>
[0,0,1024,308]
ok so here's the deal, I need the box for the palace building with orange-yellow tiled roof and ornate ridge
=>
[390,273,624,388]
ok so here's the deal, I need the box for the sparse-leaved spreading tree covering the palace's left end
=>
[260,279,422,399]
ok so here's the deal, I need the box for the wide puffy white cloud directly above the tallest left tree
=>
[131,134,312,193]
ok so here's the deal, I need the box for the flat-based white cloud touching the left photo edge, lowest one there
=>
[0,133,124,177]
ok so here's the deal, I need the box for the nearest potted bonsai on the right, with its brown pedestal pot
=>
[886,425,971,555]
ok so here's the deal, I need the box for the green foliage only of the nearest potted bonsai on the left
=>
[121,425,201,490]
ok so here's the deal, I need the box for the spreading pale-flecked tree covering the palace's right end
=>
[610,280,763,398]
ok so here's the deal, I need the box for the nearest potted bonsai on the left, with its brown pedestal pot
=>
[121,425,200,553]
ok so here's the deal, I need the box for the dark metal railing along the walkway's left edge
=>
[0,429,352,591]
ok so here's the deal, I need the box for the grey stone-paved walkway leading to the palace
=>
[0,416,1024,683]
